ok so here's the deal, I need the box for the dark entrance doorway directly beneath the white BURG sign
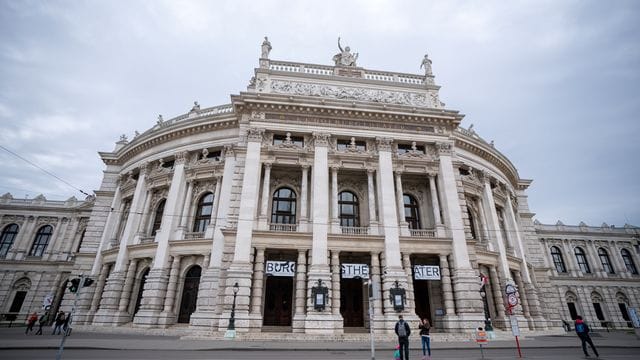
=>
[263,276,293,326]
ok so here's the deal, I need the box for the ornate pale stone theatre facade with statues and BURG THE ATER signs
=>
[0,38,640,334]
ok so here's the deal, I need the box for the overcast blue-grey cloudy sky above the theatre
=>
[0,0,640,226]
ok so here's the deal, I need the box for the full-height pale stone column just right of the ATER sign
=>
[437,142,484,328]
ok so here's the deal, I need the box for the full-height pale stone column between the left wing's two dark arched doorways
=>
[134,152,189,327]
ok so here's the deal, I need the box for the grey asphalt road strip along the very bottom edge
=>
[5,347,640,360]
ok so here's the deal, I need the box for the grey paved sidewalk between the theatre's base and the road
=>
[0,327,640,351]
